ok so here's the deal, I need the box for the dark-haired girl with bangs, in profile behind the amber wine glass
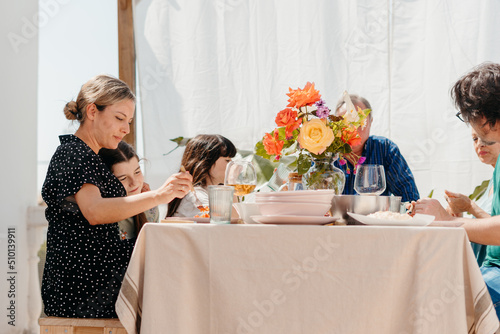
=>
[167,135,236,217]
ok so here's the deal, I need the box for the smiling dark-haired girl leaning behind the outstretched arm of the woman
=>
[99,141,159,239]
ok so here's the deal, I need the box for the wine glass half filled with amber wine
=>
[224,160,257,202]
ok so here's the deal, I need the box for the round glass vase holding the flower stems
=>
[303,155,345,195]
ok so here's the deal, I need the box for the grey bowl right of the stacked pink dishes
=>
[330,195,401,225]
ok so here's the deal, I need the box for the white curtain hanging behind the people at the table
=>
[134,0,500,204]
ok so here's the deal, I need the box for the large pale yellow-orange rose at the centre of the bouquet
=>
[297,118,335,154]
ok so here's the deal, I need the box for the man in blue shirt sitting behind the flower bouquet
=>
[335,94,420,202]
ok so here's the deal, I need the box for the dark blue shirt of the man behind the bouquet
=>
[335,136,420,202]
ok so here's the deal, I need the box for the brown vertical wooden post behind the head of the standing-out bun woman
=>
[117,0,136,147]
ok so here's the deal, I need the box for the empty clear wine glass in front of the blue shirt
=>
[354,165,386,195]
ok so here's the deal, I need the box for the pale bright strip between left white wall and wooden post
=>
[38,0,118,193]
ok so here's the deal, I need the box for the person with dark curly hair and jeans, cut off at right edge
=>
[415,63,500,318]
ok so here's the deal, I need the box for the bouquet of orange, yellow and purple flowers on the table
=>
[255,82,370,187]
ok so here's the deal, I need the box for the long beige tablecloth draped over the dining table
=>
[116,224,498,334]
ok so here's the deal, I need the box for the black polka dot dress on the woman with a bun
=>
[42,135,134,318]
